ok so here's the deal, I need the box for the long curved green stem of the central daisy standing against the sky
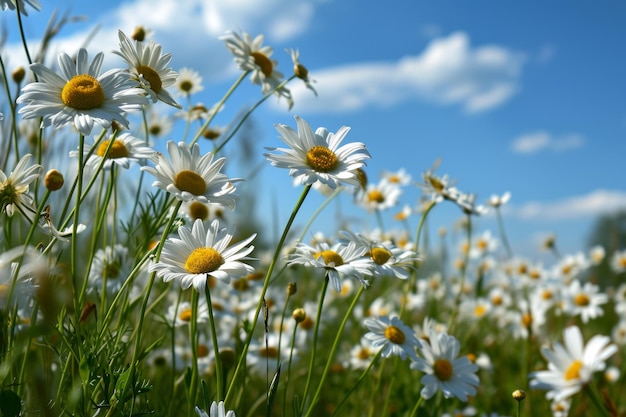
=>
[224,185,311,403]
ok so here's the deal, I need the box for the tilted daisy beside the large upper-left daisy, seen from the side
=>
[113,31,181,108]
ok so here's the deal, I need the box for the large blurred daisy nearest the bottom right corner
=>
[530,326,617,401]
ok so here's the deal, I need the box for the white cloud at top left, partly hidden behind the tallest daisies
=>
[2,0,323,81]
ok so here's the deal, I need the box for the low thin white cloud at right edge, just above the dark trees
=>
[505,189,626,221]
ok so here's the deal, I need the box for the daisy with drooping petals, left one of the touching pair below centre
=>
[289,237,372,293]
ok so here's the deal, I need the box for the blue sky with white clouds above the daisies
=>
[0,0,626,256]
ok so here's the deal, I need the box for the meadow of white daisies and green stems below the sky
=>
[0,0,626,417]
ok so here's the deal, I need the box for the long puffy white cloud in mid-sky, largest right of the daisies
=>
[292,32,525,113]
